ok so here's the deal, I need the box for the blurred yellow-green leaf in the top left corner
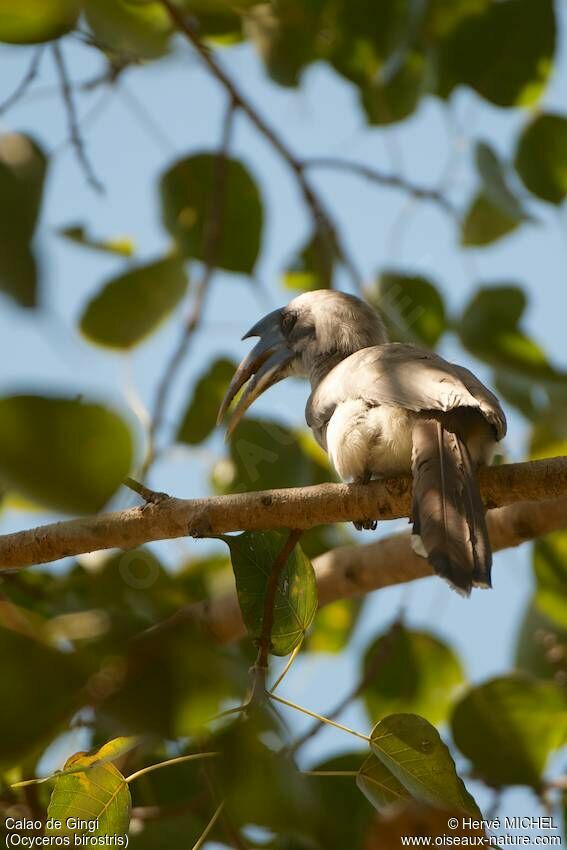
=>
[0,0,80,44]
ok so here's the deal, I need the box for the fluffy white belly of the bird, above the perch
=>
[326,399,412,481]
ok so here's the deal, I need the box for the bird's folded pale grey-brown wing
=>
[306,343,506,439]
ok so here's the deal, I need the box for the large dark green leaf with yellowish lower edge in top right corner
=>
[441,0,556,106]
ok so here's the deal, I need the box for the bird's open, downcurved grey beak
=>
[217,310,295,439]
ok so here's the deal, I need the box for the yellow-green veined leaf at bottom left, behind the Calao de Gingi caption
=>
[47,753,131,840]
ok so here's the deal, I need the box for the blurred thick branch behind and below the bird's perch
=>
[189,496,567,643]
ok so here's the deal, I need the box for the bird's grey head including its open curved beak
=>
[218,289,387,436]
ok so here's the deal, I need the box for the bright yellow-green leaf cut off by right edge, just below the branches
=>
[534,530,567,628]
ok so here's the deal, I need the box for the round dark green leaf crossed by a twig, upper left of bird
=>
[161,153,263,274]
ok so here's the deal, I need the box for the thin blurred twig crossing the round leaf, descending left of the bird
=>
[140,95,236,479]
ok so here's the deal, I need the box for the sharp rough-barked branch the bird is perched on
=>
[0,457,567,569]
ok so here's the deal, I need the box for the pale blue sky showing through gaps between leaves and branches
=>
[0,4,567,846]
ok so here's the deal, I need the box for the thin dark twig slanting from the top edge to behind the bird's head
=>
[161,0,362,290]
